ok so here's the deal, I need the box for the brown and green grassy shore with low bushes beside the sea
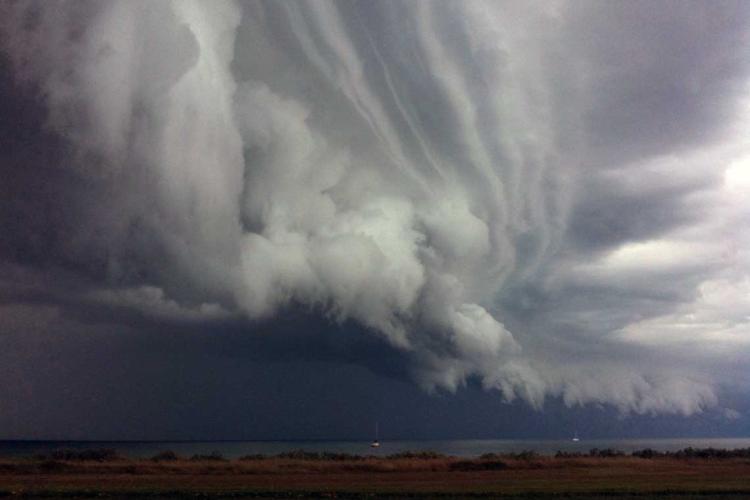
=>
[0,450,750,499]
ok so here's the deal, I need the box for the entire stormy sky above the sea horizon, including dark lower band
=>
[0,0,750,439]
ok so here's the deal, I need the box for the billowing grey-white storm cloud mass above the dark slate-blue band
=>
[0,1,750,414]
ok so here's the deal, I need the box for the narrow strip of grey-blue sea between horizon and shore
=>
[0,438,750,458]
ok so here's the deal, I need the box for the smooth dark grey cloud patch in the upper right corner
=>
[570,1,750,167]
